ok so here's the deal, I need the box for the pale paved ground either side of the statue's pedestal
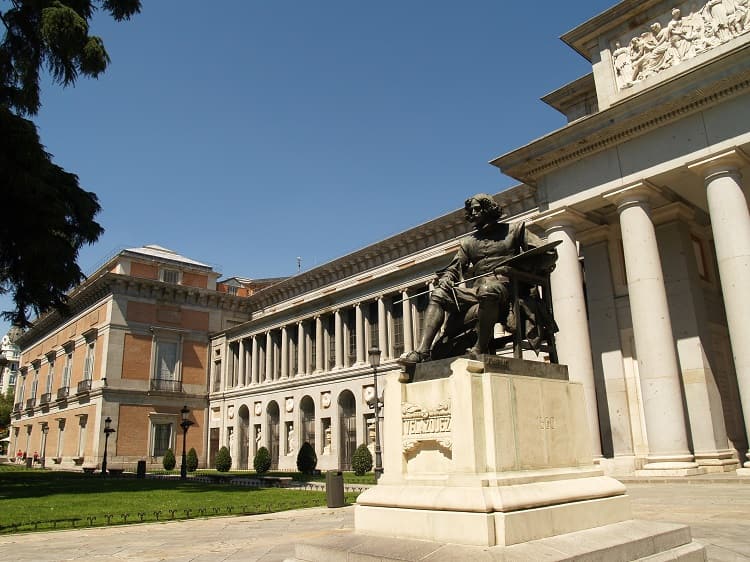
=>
[0,477,750,562]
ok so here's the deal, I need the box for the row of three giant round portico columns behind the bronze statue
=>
[534,150,750,475]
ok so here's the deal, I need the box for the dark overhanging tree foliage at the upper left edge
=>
[0,0,141,327]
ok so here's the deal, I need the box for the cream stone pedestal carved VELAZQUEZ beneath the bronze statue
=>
[297,356,701,560]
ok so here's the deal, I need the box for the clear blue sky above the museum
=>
[0,0,615,333]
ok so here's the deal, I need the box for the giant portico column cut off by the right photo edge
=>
[689,149,750,468]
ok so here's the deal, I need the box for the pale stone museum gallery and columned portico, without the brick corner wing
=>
[207,0,750,474]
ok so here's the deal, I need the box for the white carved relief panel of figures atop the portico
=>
[612,0,750,90]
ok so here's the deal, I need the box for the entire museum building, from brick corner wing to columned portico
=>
[11,0,750,475]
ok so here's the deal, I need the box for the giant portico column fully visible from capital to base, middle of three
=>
[605,182,700,475]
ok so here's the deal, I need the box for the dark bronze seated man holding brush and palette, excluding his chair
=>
[399,193,542,365]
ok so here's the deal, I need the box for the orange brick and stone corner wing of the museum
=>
[10,246,256,470]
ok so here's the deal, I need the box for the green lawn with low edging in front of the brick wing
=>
[0,466,357,533]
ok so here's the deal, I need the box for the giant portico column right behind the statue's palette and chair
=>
[534,208,602,459]
